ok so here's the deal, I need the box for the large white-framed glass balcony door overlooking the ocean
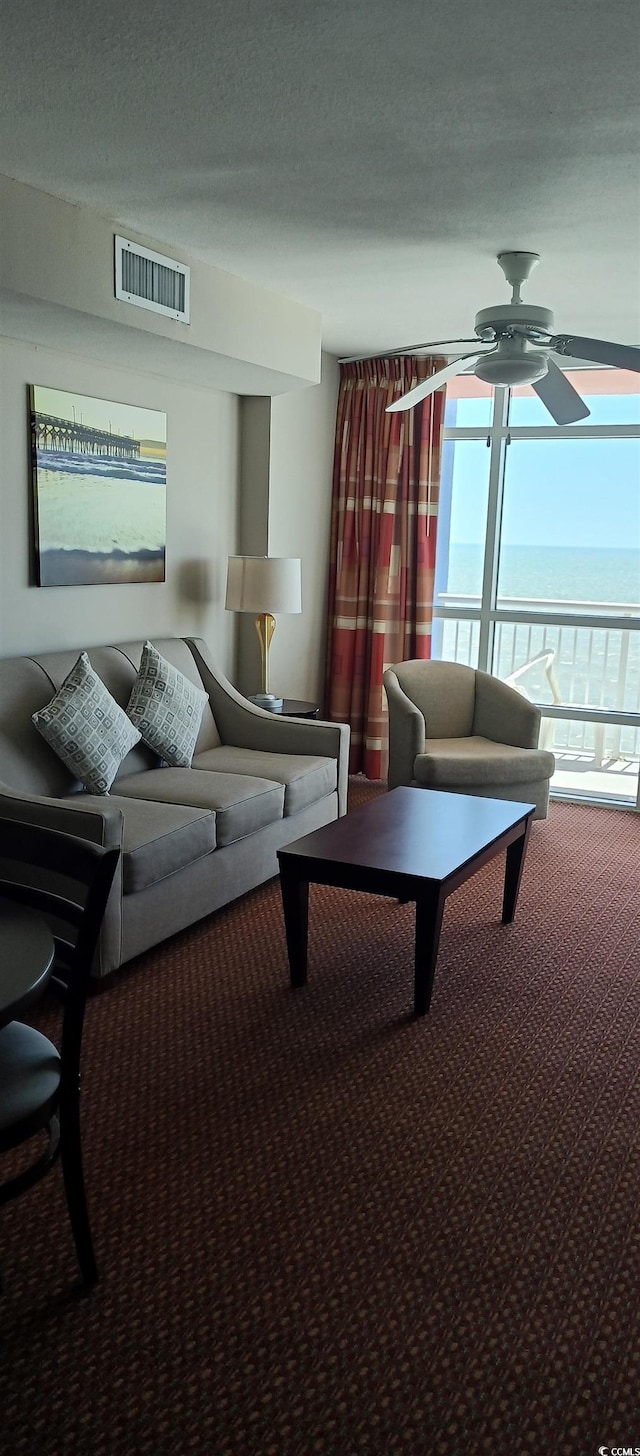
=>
[432,370,640,807]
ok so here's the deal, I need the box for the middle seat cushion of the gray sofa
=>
[118,769,285,847]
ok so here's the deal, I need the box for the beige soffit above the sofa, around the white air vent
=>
[0,176,321,395]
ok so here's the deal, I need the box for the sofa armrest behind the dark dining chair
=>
[0,783,124,977]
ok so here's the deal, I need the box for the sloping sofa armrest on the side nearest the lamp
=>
[185,638,351,814]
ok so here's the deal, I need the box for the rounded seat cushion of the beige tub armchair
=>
[413,737,556,789]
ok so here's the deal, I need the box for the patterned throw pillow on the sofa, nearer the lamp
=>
[127,642,208,769]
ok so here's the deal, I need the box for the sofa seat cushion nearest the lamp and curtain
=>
[192,744,337,818]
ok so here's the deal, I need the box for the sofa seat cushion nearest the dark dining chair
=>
[71,792,217,895]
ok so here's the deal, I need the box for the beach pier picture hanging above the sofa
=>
[29,384,167,587]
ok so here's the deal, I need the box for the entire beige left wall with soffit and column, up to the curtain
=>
[0,178,337,702]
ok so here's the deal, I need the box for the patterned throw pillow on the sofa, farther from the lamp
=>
[31,652,140,794]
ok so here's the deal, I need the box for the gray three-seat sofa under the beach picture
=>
[0,638,349,977]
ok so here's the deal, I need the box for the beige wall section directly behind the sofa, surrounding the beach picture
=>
[0,339,239,670]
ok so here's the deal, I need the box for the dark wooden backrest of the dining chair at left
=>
[0,817,119,1076]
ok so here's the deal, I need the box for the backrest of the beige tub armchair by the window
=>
[394,658,476,738]
